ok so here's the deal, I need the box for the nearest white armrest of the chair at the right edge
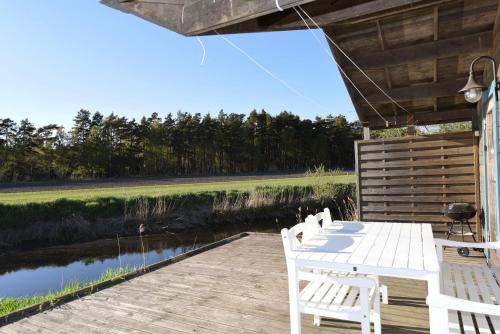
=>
[427,294,500,316]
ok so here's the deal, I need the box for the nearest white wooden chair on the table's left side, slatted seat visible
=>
[281,222,381,334]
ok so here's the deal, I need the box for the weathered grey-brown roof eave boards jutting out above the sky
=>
[100,0,453,36]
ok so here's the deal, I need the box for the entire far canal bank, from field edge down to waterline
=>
[0,183,355,249]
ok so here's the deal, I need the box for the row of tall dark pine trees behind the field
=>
[0,110,361,182]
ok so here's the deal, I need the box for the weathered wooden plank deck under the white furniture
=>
[0,234,483,334]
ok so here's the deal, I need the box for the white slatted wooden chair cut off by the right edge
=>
[427,239,500,334]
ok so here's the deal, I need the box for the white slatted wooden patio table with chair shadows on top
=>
[287,221,448,334]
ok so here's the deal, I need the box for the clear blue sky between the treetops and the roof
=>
[0,0,356,126]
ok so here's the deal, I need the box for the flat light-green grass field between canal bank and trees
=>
[0,174,355,204]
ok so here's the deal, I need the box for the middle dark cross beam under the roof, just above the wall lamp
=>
[343,31,493,70]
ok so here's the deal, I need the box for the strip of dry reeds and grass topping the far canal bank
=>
[0,180,354,229]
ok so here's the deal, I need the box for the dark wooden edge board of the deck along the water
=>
[0,232,250,328]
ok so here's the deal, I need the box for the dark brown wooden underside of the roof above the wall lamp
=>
[323,0,499,128]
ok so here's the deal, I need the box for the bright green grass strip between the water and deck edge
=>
[0,267,136,316]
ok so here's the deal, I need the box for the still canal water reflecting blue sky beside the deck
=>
[0,223,282,298]
